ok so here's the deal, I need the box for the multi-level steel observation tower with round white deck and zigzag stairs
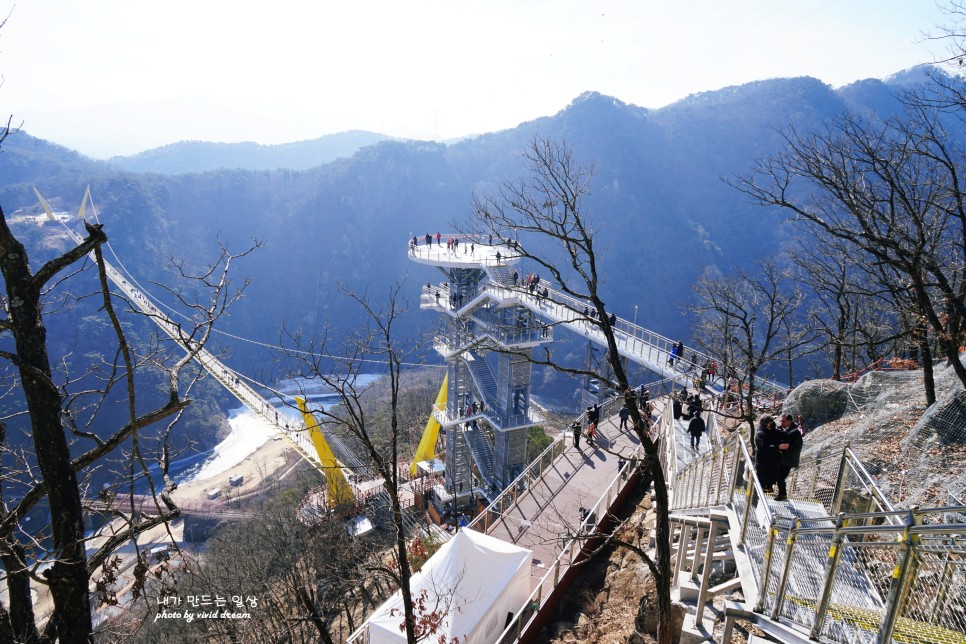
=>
[409,235,553,497]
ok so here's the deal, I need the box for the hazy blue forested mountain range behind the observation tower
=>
[0,68,944,402]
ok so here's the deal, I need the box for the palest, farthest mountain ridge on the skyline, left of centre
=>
[107,130,391,174]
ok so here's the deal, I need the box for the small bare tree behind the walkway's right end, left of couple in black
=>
[691,258,814,442]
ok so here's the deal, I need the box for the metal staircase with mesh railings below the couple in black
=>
[668,408,966,644]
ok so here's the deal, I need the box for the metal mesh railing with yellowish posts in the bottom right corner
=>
[744,507,966,642]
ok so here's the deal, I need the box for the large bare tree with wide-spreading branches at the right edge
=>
[735,102,966,392]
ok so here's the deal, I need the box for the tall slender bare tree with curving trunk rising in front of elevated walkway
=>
[470,138,672,644]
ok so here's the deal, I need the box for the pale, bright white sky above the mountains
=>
[0,0,951,158]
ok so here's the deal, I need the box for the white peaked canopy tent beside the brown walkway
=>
[369,530,533,644]
